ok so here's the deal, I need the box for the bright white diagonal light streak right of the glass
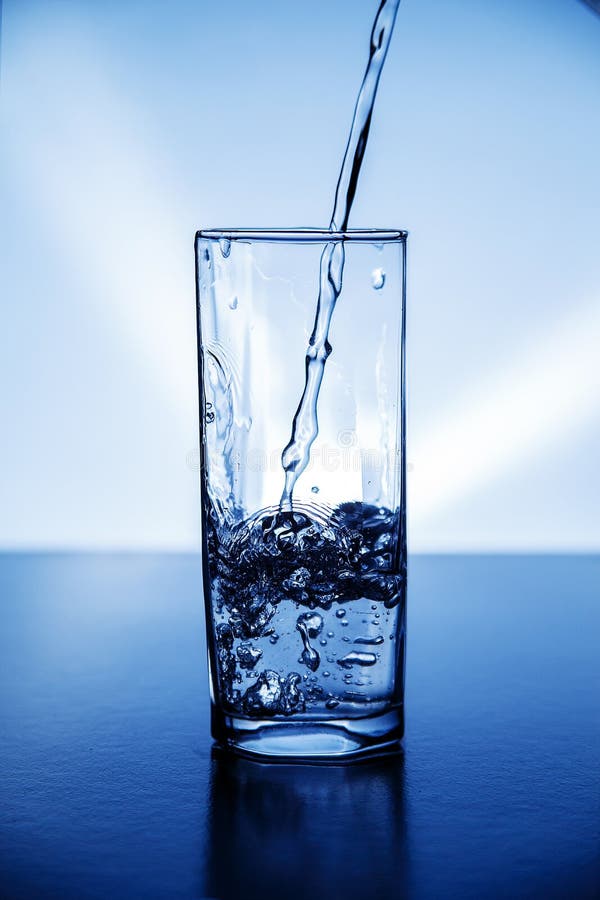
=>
[408,302,600,533]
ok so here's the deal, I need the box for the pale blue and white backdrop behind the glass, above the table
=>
[0,0,600,550]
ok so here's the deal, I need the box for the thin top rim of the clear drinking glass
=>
[196,228,408,244]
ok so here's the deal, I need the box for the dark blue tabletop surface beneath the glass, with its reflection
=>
[0,555,600,900]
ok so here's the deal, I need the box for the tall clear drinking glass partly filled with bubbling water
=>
[196,229,406,759]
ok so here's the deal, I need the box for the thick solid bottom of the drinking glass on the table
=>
[212,706,404,762]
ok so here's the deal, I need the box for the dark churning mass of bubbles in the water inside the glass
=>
[208,503,405,717]
